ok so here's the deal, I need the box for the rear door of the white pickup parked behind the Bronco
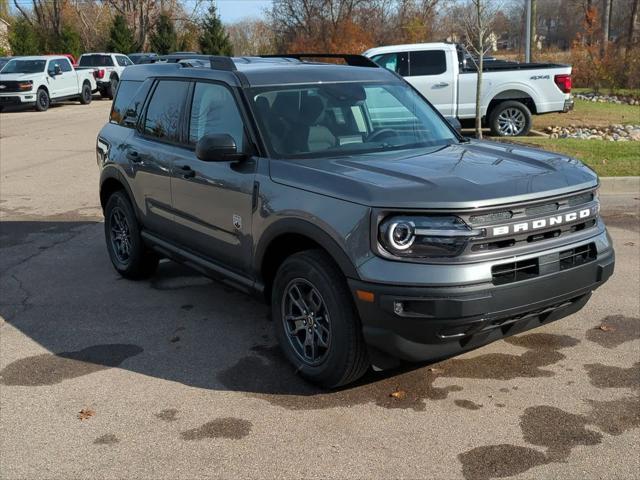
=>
[406,49,456,117]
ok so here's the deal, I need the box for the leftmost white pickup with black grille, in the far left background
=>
[0,55,97,112]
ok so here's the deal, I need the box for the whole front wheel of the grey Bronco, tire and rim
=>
[271,250,370,388]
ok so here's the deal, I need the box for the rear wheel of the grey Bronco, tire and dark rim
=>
[104,191,159,280]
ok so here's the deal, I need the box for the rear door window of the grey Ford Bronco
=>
[144,80,189,142]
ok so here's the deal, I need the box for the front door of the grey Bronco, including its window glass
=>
[171,82,256,273]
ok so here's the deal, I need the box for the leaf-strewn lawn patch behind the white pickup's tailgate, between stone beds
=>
[533,100,640,130]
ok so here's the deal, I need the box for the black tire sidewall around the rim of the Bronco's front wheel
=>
[271,254,359,384]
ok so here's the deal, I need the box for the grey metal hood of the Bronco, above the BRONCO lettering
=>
[271,141,598,208]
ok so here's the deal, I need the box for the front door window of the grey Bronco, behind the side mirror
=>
[189,83,244,151]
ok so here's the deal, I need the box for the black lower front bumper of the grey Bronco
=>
[350,233,615,363]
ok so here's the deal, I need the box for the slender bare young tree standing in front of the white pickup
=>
[462,0,499,139]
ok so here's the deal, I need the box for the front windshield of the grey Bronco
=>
[251,82,457,158]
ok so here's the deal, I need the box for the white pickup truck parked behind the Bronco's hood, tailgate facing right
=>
[364,43,573,136]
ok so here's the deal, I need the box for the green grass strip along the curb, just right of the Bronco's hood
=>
[500,137,640,177]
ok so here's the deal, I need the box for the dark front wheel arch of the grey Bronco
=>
[254,219,359,303]
